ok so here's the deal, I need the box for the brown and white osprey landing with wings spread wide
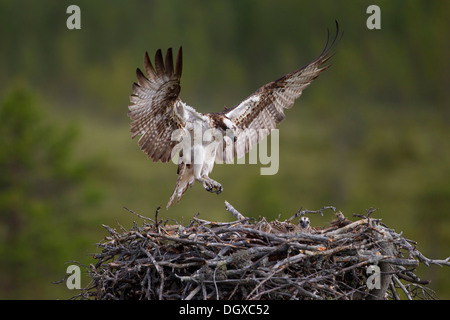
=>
[128,22,339,208]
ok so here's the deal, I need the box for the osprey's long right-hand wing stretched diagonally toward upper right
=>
[223,22,340,162]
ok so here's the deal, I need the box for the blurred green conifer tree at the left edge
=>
[0,89,99,298]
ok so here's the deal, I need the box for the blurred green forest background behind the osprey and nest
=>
[0,0,450,299]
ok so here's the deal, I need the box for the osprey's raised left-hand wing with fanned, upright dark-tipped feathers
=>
[128,47,184,162]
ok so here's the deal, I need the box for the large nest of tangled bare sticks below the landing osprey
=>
[74,202,450,300]
